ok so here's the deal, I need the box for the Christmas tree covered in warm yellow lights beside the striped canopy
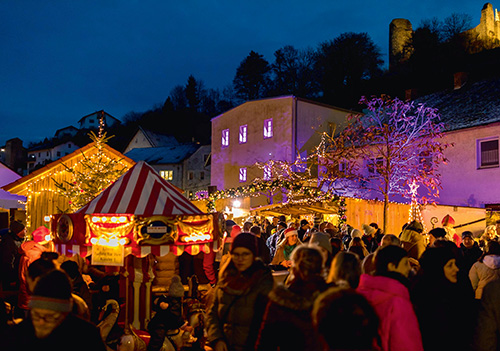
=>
[53,131,127,212]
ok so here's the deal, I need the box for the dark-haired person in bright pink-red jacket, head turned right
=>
[356,245,424,351]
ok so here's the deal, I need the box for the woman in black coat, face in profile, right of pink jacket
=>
[410,246,475,351]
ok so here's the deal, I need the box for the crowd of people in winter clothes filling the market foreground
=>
[0,216,500,351]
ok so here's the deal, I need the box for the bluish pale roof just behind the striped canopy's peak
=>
[125,143,200,165]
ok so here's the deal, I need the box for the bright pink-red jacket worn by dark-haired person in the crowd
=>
[356,274,424,351]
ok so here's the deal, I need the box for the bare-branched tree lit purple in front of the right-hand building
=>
[342,96,450,232]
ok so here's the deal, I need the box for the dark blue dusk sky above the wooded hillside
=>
[0,0,492,146]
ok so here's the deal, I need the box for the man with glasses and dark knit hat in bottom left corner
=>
[0,269,106,351]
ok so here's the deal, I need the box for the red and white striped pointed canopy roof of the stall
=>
[77,161,202,216]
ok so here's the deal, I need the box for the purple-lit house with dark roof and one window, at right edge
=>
[415,74,500,210]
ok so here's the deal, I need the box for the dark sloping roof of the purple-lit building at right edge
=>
[414,78,500,131]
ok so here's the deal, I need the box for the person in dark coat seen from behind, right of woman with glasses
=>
[256,245,328,351]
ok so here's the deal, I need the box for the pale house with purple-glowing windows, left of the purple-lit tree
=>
[211,96,352,207]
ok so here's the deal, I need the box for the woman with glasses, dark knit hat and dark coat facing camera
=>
[206,233,274,351]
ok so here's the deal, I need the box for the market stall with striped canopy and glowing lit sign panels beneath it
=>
[50,161,224,328]
